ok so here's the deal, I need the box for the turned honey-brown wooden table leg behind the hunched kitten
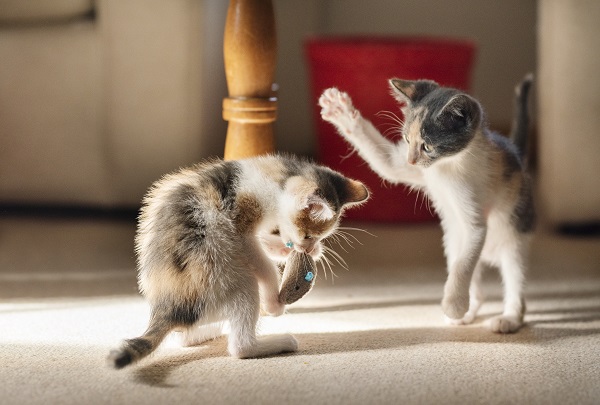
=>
[223,0,277,160]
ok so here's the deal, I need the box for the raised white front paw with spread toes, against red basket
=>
[319,87,359,136]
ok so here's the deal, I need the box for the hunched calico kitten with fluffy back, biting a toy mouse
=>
[108,156,369,368]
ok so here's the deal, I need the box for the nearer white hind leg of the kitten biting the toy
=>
[227,282,298,359]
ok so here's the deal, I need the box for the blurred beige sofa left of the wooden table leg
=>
[0,0,227,206]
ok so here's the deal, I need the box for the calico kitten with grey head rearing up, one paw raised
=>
[319,76,534,333]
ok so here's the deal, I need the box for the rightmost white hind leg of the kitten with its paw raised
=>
[490,249,525,333]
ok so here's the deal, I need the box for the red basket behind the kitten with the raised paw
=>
[305,37,476,222]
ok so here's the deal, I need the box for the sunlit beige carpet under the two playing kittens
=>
[0,218,600,404]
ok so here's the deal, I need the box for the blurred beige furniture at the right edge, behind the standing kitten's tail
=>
[538,0,600,225]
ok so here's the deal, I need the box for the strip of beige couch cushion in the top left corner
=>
[0,0,94,23]
